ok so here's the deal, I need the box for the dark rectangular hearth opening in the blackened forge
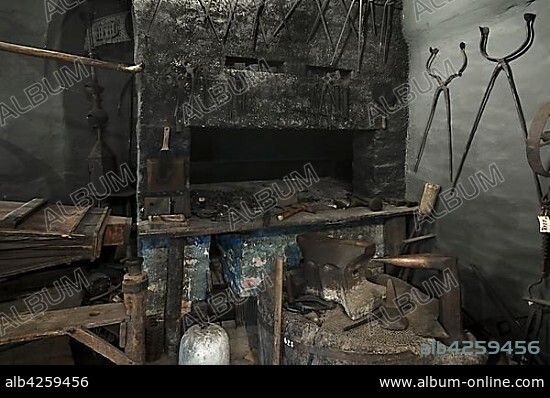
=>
[190,127,354,184]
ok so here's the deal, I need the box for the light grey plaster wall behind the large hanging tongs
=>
[404,0,550,332]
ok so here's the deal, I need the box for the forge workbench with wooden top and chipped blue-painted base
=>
[138,180,417,353]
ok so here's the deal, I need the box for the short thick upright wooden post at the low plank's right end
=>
[122,259,148,364]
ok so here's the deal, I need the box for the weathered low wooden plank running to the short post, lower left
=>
[0,303,127,345]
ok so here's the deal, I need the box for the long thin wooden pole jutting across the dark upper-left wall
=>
[0,41,143,73]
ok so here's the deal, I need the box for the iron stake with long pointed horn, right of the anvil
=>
[371,254,468,342]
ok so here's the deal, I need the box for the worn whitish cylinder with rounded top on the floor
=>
[179,324,230,365]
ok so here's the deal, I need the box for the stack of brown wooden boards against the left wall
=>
[0,199,131,277]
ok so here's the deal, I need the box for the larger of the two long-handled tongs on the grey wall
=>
[453,14,542,201]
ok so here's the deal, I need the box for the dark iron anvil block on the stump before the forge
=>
[297,233,385,320]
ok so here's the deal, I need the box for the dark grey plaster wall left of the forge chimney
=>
[0,0,135,204]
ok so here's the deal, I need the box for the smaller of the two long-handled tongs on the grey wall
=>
[413,43,468,182]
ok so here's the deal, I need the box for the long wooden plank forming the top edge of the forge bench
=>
[138,206,417,238]
